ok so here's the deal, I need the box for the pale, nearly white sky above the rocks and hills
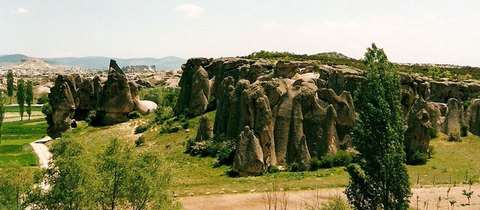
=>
[0,0,480,66]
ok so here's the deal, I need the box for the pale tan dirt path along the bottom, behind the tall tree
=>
[180,185,480,210]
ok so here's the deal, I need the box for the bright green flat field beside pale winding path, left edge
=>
[0,119,47,167]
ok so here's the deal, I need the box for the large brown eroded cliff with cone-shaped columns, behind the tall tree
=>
[176,58,480,175]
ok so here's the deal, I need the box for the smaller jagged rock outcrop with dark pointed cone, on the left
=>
[46,60,156,138]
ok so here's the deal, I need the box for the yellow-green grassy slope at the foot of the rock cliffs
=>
[57,112,480,196]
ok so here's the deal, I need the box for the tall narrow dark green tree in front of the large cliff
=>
[345,44,411,210]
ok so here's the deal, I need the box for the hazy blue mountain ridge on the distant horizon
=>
[0,54,186,70]
